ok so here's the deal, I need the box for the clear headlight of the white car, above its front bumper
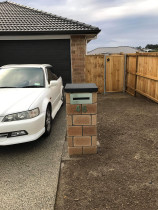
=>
[2,108,40,122]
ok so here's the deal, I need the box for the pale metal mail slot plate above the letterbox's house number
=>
[70,93,92,104]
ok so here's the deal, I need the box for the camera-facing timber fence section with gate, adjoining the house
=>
[85,55,124,93]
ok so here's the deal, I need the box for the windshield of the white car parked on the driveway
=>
[0,67,44,88]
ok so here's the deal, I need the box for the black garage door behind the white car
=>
[0,39,71,84]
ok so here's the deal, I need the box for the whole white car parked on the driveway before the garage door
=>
[0,64,64,146]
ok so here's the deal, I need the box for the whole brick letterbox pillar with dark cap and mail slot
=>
[65,84,98,156]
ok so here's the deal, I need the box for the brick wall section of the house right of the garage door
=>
[71,35,87,83]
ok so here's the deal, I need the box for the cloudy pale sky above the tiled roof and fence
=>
[0,0,158,51]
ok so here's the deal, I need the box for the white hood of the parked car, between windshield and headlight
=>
[0,88,44,116]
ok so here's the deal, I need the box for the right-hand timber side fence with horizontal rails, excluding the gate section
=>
[126,53,158,102]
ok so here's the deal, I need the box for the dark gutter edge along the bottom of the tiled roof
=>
[0,29,101,35]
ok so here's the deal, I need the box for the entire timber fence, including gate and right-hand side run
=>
[85,53,158,102]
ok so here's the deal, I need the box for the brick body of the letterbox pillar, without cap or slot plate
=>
[66,92,97,156]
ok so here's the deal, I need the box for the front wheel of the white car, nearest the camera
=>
[44,106,52,136]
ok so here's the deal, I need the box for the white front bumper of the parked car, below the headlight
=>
[0,112,45,146]
